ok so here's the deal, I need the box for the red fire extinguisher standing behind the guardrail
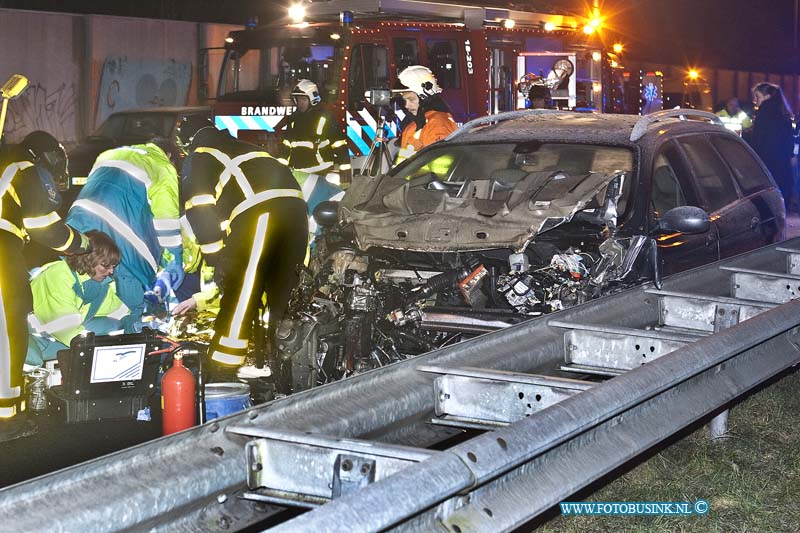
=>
[161,354,195,435]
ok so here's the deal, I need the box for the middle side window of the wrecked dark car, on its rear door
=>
[678,135,739,212]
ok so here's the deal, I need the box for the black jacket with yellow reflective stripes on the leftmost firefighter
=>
[0,145,89,252]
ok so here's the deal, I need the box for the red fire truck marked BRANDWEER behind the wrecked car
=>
[212,0,609,162]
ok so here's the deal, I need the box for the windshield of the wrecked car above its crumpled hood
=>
[362,141,634,212]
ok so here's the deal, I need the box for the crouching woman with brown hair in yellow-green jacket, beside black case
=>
[25,230,128,366]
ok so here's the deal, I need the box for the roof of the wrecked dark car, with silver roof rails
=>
[448,109,727,146]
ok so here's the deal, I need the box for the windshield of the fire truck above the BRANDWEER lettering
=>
[218,39,335,106]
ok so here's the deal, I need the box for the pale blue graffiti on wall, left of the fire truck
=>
[96,56,192,124]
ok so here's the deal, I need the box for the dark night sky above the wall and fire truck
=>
[0,0,800,74]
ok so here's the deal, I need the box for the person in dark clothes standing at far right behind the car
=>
[750,82,795,207]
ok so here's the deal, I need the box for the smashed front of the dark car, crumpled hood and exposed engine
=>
[275,141,652,391]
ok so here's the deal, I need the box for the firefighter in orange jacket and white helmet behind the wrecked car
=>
[395,65,457,164]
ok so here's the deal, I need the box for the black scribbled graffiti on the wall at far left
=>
[4,83,77,141]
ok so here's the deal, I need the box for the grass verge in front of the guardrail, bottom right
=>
[537,369,800,533]
